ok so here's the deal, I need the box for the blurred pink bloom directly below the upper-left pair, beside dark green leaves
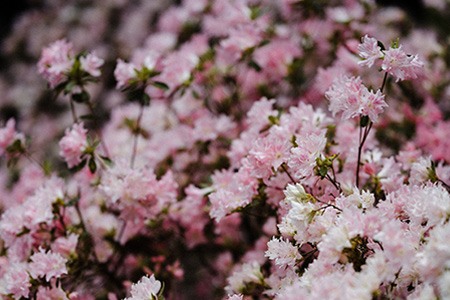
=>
[59,123,88,168]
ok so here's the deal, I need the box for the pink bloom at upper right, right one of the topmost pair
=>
[381,46,424,82]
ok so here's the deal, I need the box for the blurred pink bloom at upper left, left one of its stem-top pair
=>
[38,39,74,88]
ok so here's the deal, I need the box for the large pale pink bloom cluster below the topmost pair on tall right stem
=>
[325,76,388,122]
